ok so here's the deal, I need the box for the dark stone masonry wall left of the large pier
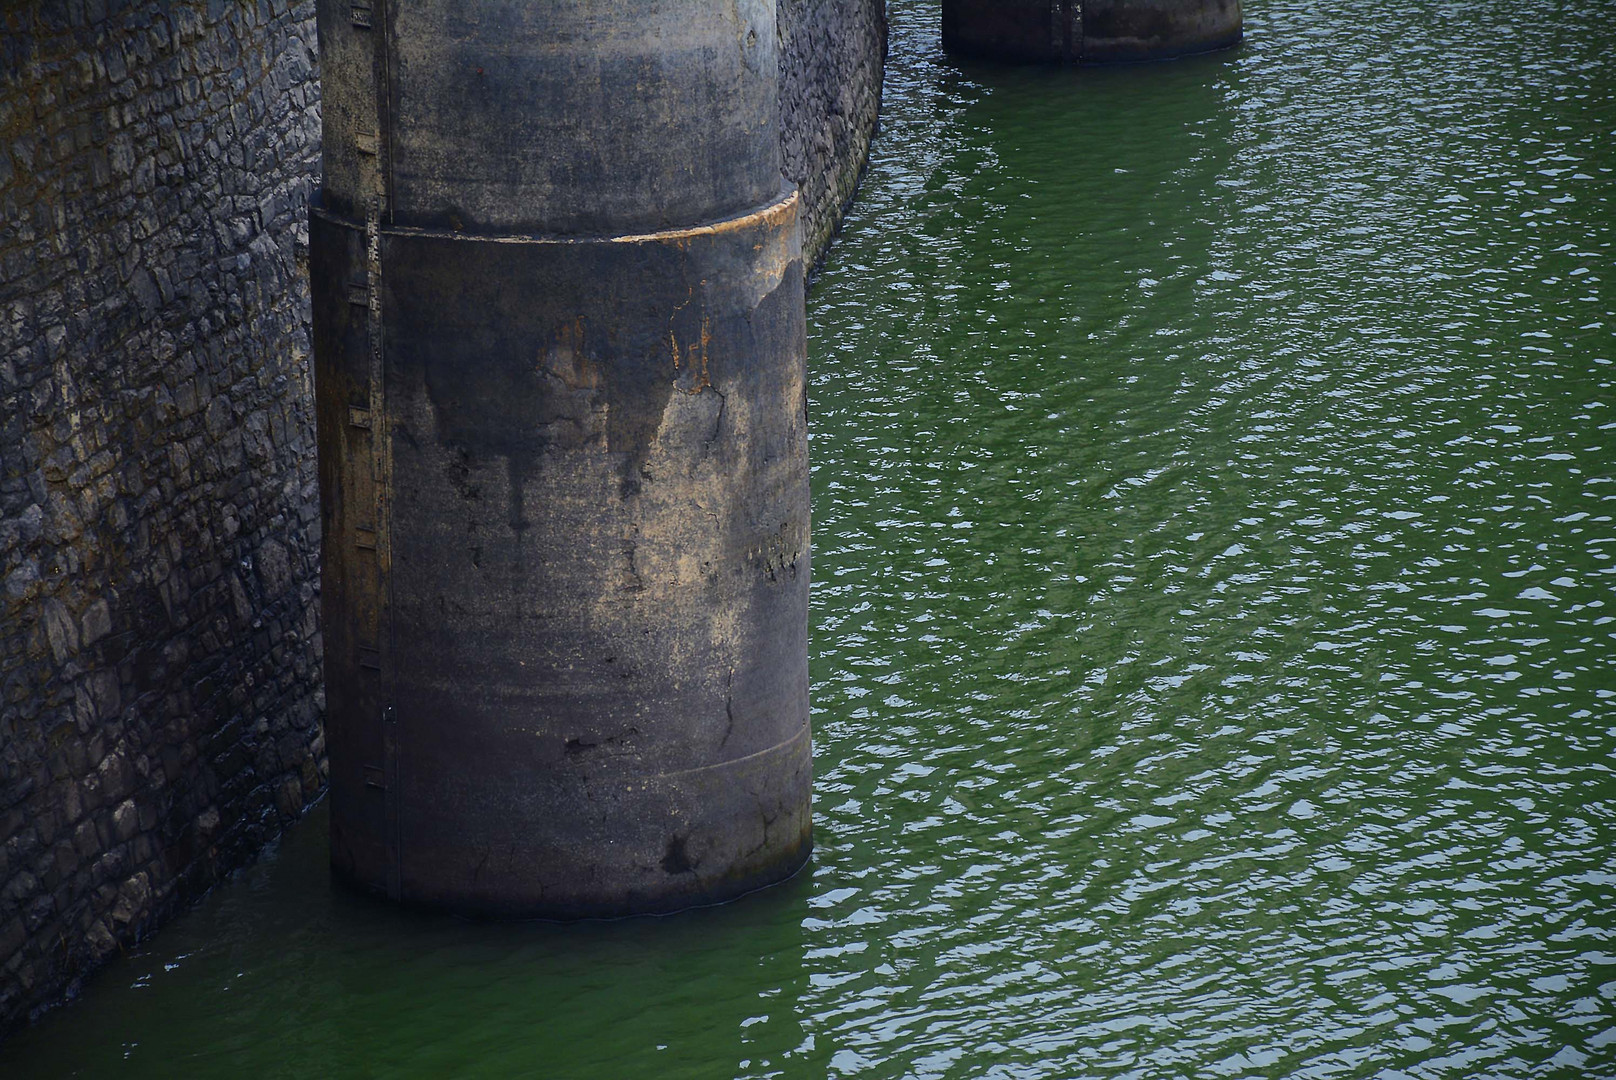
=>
[0,0,325,1031]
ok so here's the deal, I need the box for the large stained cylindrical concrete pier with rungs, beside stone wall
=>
[310,0,811,917]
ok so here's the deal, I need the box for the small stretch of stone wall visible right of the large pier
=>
[776,0,887,267]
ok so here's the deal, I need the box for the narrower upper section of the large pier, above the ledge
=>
[320,0,781,236]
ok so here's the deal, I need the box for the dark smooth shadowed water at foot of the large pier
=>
[0,805,823,1078]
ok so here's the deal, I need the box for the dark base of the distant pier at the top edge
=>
[942,0,1241,63]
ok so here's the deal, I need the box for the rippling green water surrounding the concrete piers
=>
[0,0,1616,1080]
